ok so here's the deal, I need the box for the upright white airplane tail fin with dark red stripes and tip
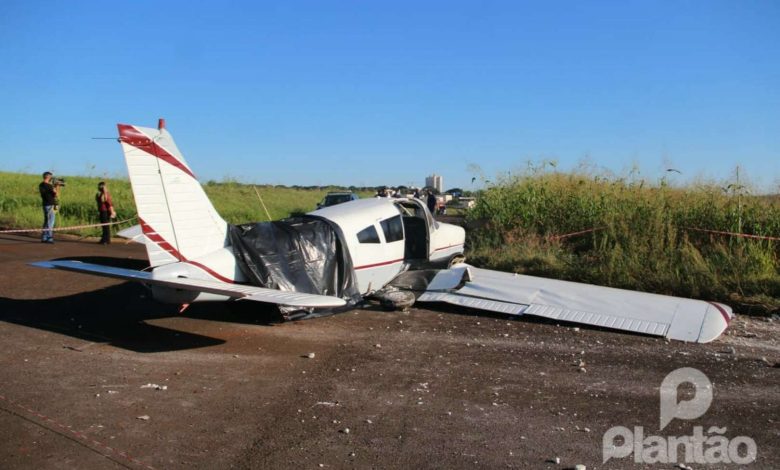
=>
[117,119,228,267]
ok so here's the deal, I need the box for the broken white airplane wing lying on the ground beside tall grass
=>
[417,264,733,343]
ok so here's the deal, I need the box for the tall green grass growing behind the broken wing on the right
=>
[468,170,780,311]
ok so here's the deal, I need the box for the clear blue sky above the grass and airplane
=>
[0,0,780,190]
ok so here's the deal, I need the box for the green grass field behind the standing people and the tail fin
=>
[0,172,372,236]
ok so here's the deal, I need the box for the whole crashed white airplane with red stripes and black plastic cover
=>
[33,119,734,343]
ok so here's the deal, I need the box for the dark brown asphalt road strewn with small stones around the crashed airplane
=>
[0,235,780,469]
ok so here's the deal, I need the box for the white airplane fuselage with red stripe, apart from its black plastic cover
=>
[152,198,466,304]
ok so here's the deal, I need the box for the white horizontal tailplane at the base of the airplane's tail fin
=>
[31,261,346,308]
